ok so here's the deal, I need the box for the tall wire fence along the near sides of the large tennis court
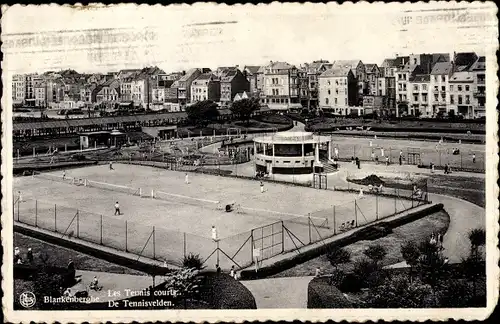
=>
[14,175,428,269]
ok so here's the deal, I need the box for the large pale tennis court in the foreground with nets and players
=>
[14,164,420,268]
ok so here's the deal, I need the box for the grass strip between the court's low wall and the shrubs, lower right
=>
[274,211,450,277]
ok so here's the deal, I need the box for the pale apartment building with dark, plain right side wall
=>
[318,67,358,115]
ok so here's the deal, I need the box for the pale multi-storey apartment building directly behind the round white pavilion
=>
[261,61,301,110]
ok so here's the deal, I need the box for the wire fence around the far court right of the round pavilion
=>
[332,140,485,172]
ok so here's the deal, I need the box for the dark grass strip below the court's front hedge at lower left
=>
[14,233,145,275]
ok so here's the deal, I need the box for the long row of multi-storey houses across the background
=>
[12,53,486,118]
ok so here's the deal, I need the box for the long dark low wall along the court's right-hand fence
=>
[241,204,443,279]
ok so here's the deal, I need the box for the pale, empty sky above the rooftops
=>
[2,3,498,73]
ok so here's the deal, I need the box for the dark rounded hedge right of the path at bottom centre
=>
[307,277,355,308]
